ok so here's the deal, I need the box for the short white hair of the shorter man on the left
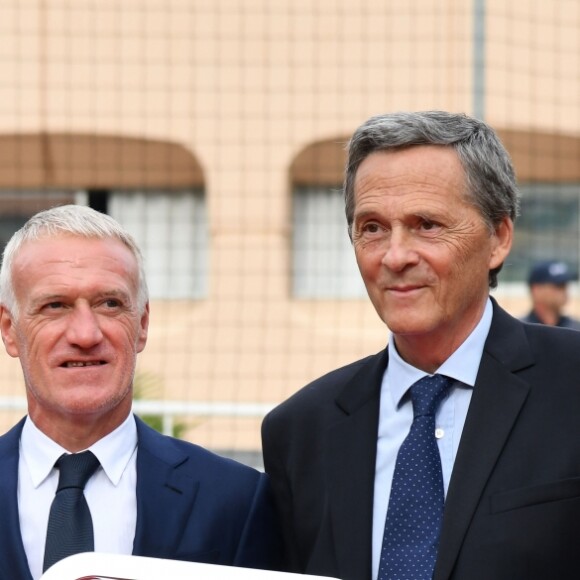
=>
[0,205,149,318]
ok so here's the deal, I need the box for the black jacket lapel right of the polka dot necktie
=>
[434,302,533,580]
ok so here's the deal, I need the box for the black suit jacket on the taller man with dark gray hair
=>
[262,302,580,580]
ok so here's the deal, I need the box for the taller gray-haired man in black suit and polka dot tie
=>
[262,111,580,580]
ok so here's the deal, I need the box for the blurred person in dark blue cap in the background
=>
[522,260,580,330]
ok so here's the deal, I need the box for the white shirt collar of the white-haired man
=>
[20,414,137,488]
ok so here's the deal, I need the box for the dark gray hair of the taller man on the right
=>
[344,111,519,288]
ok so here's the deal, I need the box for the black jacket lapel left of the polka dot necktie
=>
[325,351,387,580]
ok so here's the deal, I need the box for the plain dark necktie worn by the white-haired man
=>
[43,451,99,571]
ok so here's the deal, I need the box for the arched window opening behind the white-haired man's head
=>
[0,134,209,299]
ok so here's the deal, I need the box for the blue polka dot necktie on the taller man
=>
[378,375,451,580]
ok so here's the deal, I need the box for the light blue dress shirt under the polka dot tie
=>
[373,299,492,578]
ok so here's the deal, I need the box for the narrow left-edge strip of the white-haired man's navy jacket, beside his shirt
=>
[0,419,32,580]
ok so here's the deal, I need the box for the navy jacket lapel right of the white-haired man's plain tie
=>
[133,418,198,558]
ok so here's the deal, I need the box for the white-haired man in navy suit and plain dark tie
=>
[0,206,279,580]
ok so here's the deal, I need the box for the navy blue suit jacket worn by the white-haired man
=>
[0,418,280,580]
